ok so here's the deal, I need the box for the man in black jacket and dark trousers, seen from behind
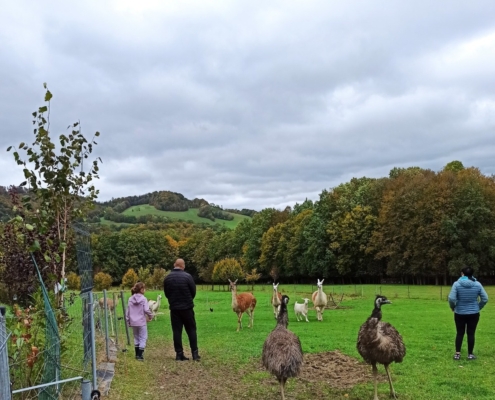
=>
[163,258,201,361]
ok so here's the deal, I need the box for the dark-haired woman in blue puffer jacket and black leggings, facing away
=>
[449,267,488,360]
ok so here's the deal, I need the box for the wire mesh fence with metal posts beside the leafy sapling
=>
[0,223,99,400]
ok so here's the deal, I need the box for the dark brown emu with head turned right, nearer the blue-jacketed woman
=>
[357,295,406,400]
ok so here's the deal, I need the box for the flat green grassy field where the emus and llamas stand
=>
[103,285,495,400]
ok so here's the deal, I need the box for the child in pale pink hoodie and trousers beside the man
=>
[125,282,153,361]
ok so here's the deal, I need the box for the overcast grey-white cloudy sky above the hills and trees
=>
[0,0,495,210]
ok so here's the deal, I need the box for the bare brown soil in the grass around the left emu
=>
[126,347,378,400]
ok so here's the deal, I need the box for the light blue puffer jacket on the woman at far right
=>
[449,276,488,315]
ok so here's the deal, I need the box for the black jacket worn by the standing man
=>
[163,268,196,310]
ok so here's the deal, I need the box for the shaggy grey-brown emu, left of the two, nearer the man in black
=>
[262,295,303,400]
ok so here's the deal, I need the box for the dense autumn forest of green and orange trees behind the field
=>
[79,161,495,284]
